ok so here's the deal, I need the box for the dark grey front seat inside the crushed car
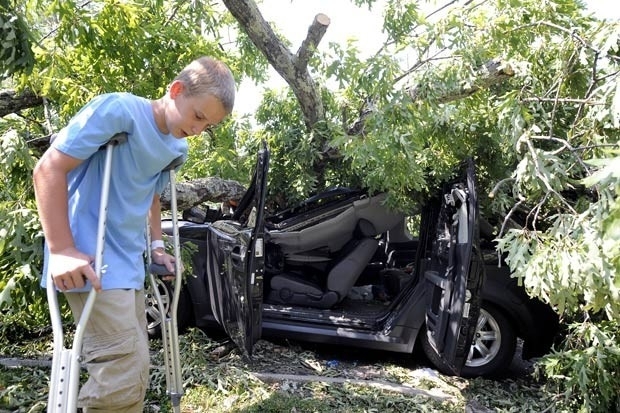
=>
[269,237,379,308]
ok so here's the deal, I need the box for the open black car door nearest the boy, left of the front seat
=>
[206,142,269,357]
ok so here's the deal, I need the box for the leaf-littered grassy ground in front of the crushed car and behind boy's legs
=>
[0,329,567,413]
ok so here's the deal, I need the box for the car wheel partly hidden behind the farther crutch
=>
[145,278,194,339]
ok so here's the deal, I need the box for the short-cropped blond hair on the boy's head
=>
[174,56,235,113]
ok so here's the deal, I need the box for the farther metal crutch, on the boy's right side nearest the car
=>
[146,157,183,413]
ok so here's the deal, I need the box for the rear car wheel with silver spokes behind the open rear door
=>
[421,303,517,377]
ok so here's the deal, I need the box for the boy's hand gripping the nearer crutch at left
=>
[49,247,101,291]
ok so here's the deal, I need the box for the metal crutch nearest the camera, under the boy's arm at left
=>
[47,132,127,413]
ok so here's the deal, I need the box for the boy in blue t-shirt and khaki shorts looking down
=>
[33,57,235,412]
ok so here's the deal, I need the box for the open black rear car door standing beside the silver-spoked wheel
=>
[423,160,484,375]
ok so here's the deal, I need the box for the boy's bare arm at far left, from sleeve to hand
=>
[33,148,101,291]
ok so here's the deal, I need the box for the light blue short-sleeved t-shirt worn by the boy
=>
[42,93,188,291]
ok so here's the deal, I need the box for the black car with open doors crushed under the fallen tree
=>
[147,148,558,376]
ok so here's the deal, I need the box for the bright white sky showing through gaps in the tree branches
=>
[235,0,620,115]
